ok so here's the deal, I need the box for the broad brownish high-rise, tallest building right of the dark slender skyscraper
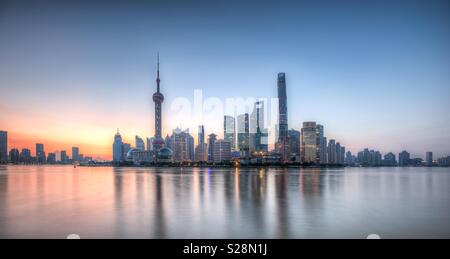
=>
[300,121,320,164]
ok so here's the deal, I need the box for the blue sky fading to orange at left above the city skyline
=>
[0,0,450,159]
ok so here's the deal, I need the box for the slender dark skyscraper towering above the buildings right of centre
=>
[277,73,290,162]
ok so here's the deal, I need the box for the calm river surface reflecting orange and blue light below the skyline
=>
[0,166,450,238]
